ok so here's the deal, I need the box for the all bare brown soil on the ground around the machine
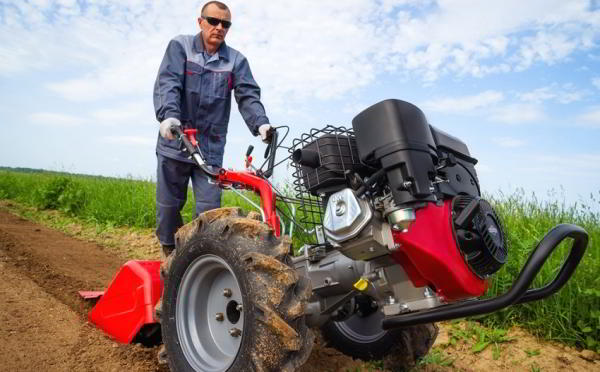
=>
[0,206,600,372]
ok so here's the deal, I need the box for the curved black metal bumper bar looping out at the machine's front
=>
[381,224,588,329]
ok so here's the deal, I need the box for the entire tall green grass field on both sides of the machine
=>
[0,169,600,351]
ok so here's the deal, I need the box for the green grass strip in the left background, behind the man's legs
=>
[0,170,266,228]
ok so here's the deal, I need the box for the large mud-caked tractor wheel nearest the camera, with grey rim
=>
[160,208,314,372]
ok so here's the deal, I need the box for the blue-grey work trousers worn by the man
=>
[156,154,221,245]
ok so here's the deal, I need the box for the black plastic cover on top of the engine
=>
[352,99,480,206]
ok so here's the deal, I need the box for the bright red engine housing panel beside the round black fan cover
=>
[392,200,488,301]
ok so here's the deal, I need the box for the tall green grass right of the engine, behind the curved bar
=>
[483,191,600,350]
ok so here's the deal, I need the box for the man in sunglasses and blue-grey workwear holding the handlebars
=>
[154,1,271,257]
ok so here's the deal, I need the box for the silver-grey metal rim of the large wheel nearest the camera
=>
[175,255,244,372]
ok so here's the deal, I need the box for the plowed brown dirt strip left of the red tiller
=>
[0,211,164,371]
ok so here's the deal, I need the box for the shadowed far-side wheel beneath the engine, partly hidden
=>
[321,297,438,371]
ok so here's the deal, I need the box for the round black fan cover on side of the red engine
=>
[452,195,508,278]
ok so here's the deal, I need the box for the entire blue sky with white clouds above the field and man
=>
[0,0,600,203]
